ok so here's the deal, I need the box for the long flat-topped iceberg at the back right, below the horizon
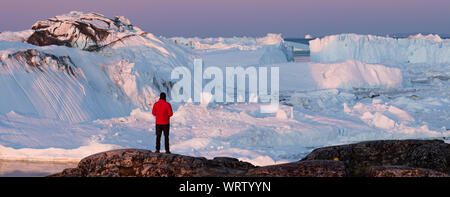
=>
[309,34,450,64]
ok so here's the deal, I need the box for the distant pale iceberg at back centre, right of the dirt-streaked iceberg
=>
[170,33,294,66]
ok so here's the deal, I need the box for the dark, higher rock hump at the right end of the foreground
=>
[303,140,450,176]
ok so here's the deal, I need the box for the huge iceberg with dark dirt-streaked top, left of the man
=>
[0,12,192,122]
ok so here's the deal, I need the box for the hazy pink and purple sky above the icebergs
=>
[0,0,450,37]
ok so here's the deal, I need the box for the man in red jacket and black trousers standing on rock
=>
[152,92,173,154]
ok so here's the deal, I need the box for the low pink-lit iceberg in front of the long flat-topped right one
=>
[279,60,402,91]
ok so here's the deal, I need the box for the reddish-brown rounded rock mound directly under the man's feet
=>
[52,149,255,177]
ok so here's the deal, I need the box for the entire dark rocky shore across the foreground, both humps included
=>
[52,140,450,177]
